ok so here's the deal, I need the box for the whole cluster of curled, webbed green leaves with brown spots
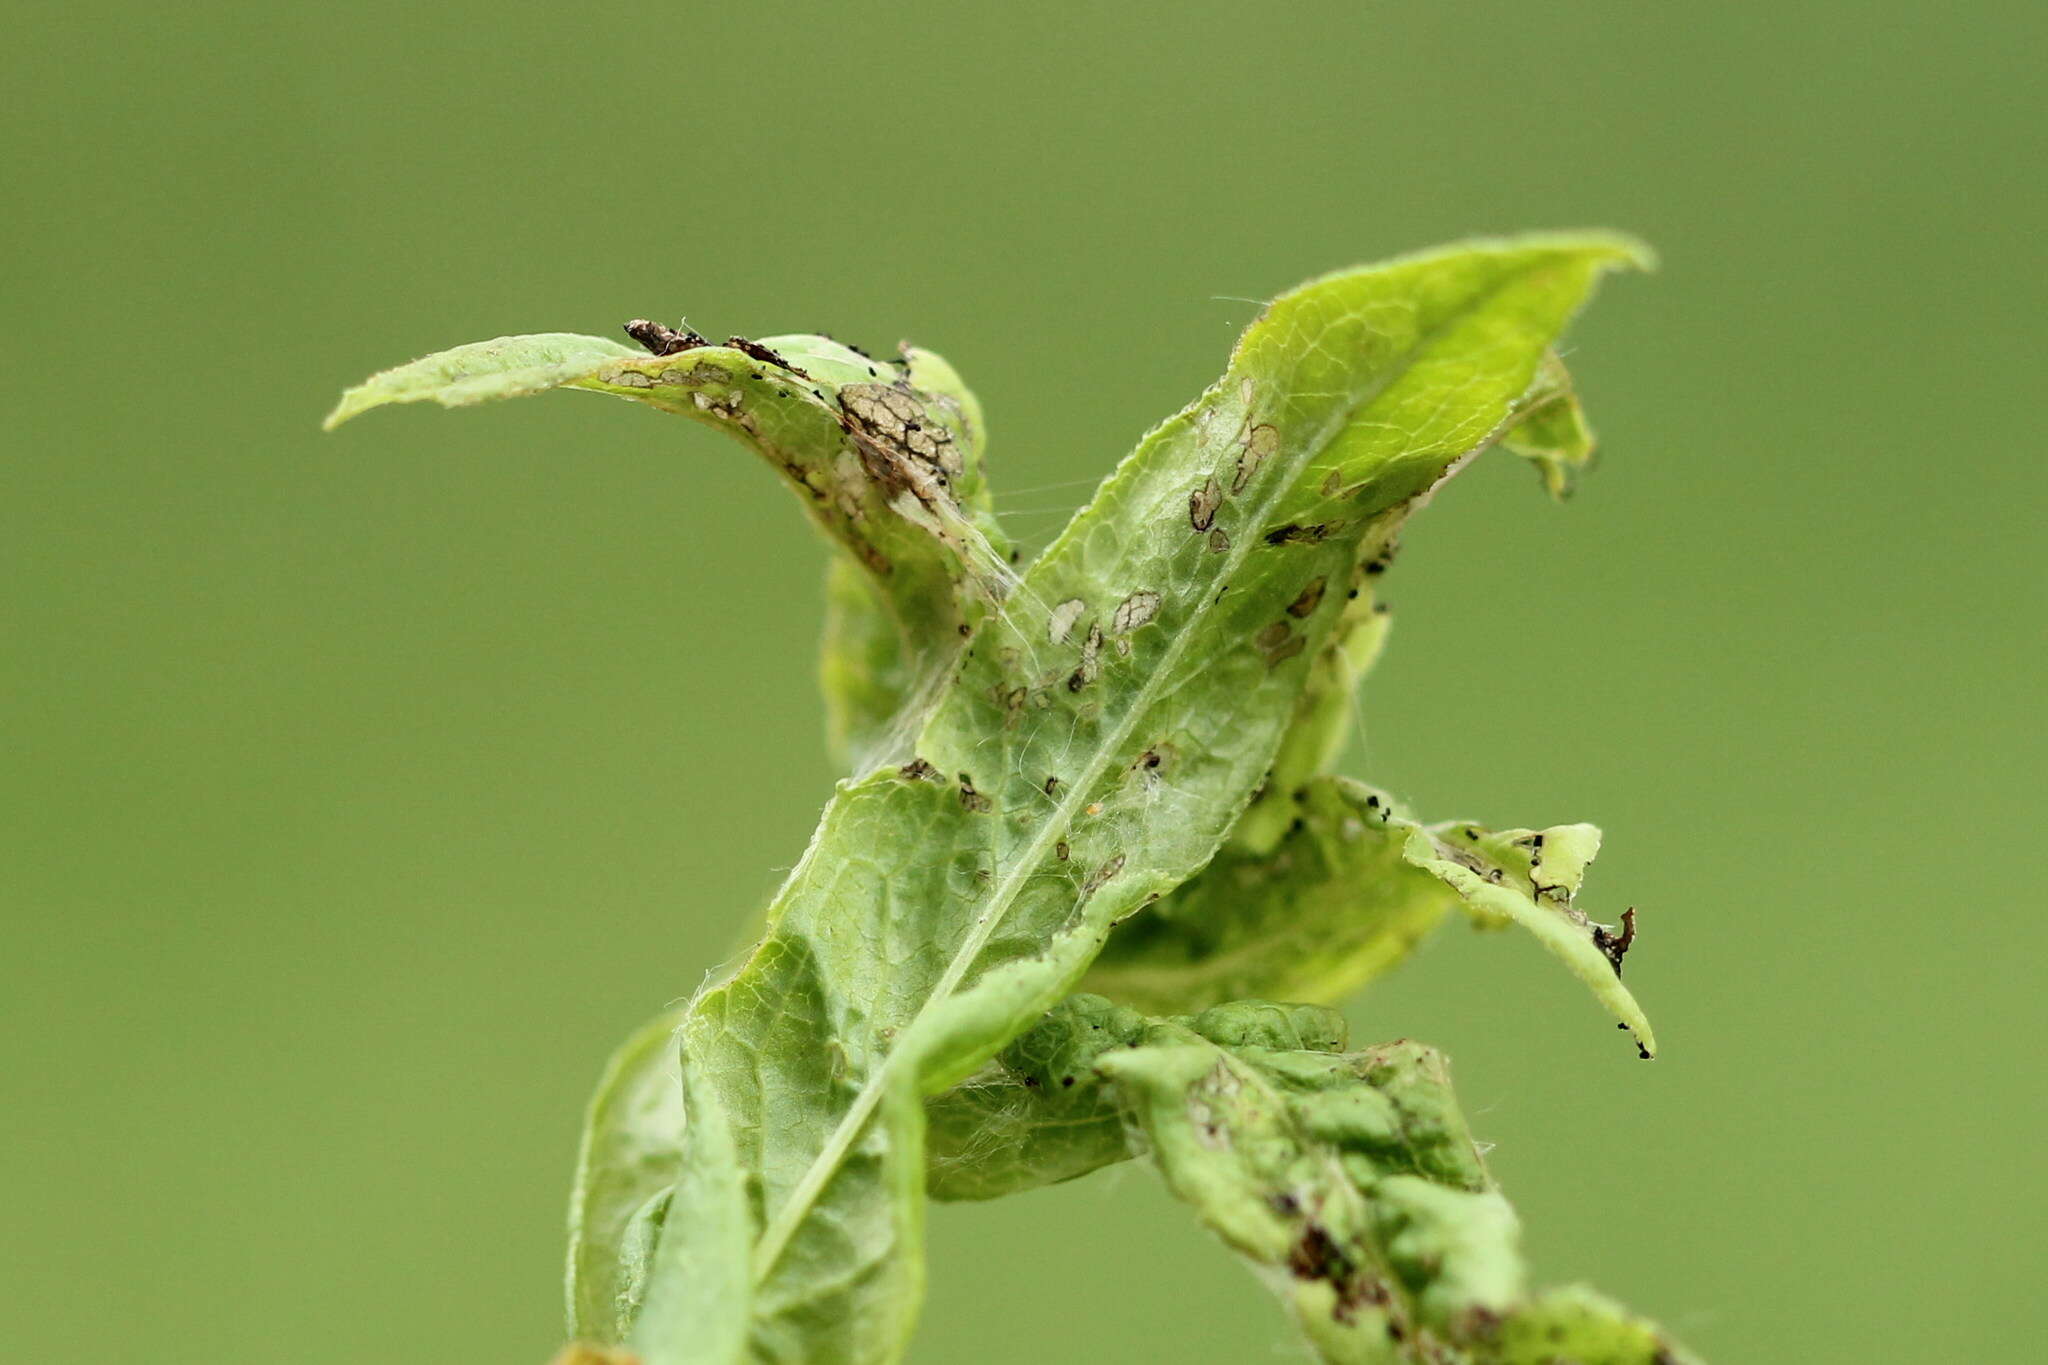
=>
[330,233,1679,1365]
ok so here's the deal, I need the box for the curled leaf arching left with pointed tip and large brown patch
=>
[326,334,1016,767]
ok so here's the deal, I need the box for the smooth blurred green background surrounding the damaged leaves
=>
[0,0,2048,1365]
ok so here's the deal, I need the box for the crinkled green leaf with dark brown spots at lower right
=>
[1096,1023,1681,1365]
